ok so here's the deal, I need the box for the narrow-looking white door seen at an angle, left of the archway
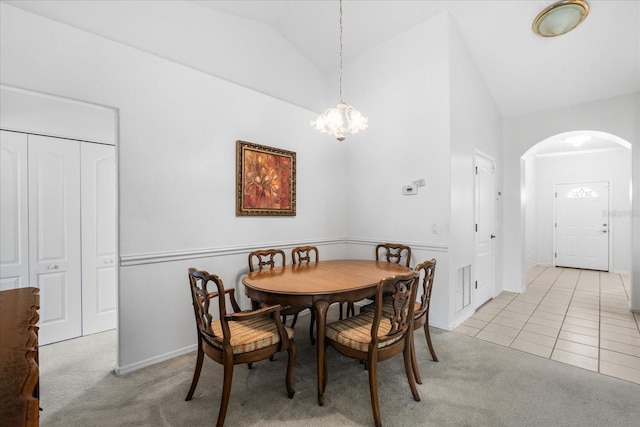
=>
[473,154,496,308]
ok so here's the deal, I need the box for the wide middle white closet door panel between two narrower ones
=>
[28,135,82,345]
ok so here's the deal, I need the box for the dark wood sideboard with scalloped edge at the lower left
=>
[0,288,40,427]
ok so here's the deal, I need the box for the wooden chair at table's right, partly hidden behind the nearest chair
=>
[360,259,438,384]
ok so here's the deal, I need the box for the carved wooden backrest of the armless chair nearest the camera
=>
[369,271,419,350]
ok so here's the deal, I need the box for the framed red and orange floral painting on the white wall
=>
[236,141,296,216]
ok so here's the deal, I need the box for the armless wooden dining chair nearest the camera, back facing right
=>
[321,271,420,426]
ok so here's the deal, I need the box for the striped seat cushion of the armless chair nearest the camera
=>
[326,311,402,351]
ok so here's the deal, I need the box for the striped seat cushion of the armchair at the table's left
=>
[211,316,293,354]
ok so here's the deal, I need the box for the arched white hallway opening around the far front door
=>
[521,130,632,280]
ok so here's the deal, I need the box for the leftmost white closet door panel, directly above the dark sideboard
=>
[0,131,30,290]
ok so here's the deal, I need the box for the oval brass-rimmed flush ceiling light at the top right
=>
[532,0,589,37]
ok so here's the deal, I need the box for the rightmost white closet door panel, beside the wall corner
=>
[80,143,117,335]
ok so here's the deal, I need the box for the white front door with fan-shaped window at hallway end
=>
[554,182,609,271]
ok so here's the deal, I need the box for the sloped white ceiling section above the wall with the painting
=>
[10,0,335,111]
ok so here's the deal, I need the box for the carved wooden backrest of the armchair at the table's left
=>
[189,268,234,342]
